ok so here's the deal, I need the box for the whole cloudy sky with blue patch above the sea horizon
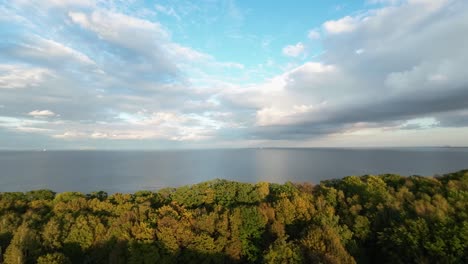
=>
[0,0,468,149]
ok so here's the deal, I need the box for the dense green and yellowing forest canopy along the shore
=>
[0,170,468,264]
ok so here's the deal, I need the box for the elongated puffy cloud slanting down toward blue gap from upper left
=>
[68,7,244,82]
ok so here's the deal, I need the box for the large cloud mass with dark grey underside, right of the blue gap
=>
[218,1,468,139]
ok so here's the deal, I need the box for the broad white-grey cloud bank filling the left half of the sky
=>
[0,2,234,141]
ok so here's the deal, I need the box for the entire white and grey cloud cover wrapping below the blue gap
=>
[0,0,468,146]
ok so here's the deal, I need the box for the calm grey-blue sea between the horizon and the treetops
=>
[0,148,468,193]
